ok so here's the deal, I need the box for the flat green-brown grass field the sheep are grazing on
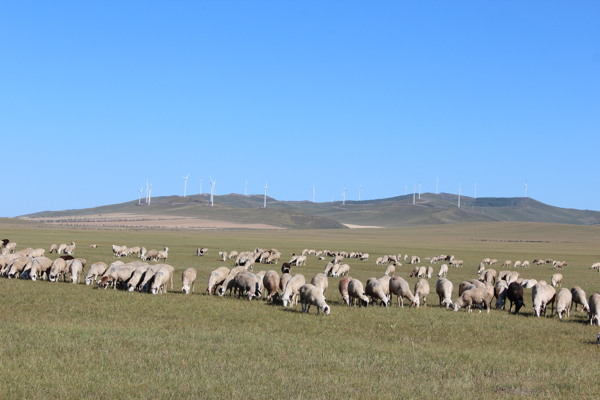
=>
[0,222,600,399]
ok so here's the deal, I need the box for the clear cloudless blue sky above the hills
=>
[0,0,600,217]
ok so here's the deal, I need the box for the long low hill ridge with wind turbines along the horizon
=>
[22,193,600,229]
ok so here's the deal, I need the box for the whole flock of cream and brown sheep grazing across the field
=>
[0,239,600,326]
